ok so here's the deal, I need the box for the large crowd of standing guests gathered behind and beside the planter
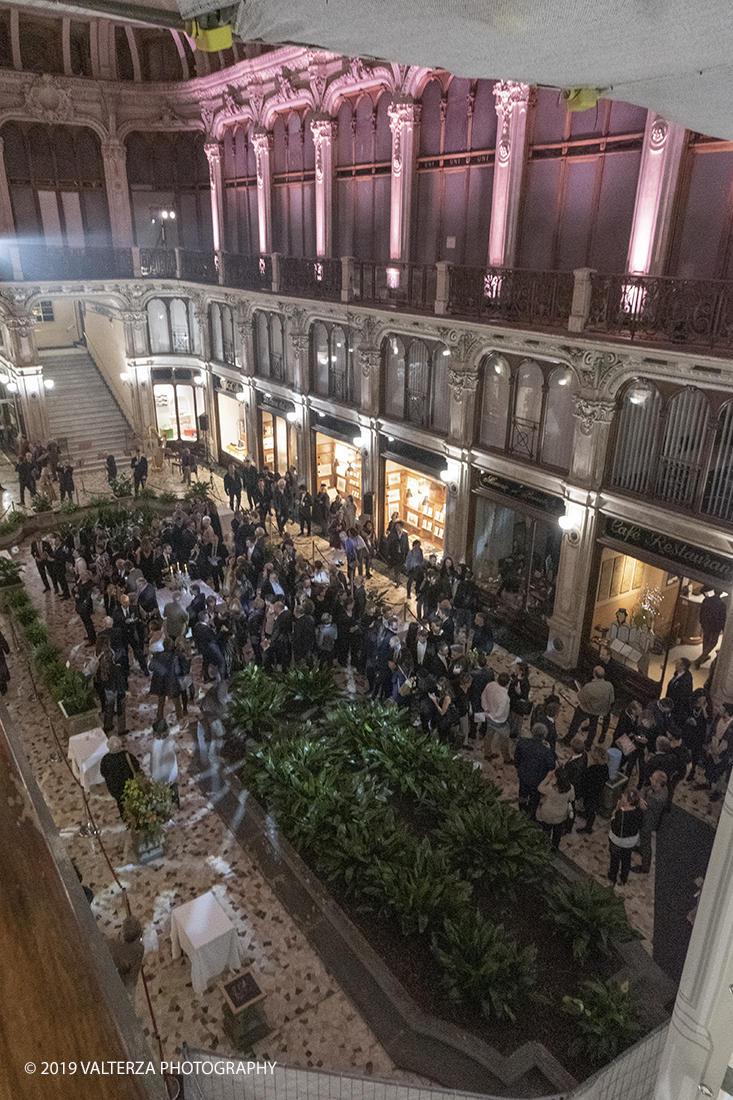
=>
[15,453,733,883]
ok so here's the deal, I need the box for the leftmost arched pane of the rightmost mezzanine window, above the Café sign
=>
[611,382,661,494]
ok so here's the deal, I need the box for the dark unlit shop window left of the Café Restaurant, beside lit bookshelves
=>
[473,497,562,622]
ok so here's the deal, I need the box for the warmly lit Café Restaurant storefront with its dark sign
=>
[589,516,733,690]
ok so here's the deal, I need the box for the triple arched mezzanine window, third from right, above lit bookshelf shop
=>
[383,337,450,431]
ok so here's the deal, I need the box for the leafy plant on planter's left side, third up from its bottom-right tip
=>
[363,837,471,935]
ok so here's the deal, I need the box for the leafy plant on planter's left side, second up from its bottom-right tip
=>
[433,910,537,1020]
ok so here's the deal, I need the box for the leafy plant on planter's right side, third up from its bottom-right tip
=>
[436,799,550,893]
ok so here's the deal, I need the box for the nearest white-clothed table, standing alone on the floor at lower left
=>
[171,890,241,993]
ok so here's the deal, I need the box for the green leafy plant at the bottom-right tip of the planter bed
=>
[562,978,645,1063]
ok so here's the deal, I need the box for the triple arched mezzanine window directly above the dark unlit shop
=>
[479,352,576,470]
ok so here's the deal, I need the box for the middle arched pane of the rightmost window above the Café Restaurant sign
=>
[656,386,710,505]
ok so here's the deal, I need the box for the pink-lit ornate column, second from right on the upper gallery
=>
[489,80,529,267]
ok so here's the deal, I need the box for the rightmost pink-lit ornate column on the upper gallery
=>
[627,111,686,275]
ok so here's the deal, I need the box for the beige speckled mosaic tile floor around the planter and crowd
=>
[0,495,719,1081]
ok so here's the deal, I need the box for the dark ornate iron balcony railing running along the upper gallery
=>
[0,241,733,353]
